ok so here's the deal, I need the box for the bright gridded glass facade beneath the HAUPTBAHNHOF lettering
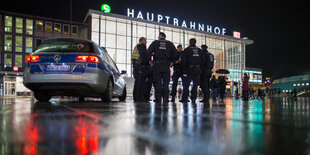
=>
[90,13,245,80]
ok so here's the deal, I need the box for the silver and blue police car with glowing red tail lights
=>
[23,38,126,102]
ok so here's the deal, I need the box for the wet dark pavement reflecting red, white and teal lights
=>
[0,97,310,155]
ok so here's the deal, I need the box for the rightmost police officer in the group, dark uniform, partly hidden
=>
[200,45,214,102]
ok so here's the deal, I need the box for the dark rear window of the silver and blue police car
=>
[35,40,94,53]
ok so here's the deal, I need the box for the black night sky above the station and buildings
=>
[0,0,310,79]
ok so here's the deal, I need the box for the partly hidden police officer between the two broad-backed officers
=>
[171,44,183,102]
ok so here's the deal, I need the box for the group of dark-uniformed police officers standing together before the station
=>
[131,32,214,103]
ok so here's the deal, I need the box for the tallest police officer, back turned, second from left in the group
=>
[148,32,177,103]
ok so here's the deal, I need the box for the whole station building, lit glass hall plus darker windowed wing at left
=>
[0,8,253,96]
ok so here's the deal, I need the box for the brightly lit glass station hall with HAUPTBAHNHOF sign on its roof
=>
[85,6,253,81]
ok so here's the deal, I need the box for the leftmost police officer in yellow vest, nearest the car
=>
[131,37,148,102]
